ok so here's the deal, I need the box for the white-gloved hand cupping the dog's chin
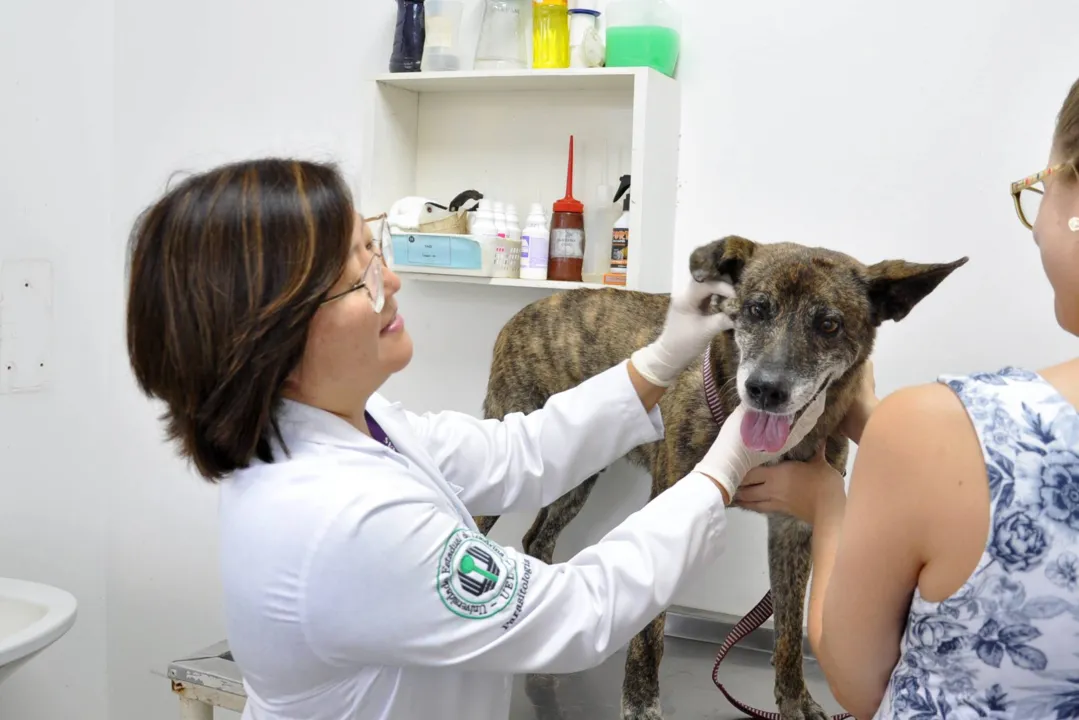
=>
[693,391,828,500]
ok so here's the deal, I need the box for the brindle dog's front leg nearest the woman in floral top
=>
[768,515,828,720]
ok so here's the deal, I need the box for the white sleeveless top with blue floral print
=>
[875,368,1079,720]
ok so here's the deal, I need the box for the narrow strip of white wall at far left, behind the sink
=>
[0,0,111,720]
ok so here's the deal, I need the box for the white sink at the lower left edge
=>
[0,578,78,682]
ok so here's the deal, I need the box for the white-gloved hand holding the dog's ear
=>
[629,279,735,388]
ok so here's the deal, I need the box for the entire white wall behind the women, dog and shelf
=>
[0,0,1079,720]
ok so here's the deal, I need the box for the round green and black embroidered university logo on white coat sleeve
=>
[437,529,518,620]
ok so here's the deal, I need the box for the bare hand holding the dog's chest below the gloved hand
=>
[733,443,846,525]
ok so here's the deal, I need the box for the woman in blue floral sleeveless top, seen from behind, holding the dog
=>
[736,74,1079,720]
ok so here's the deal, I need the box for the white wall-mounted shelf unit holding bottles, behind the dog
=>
[359,68,681,293]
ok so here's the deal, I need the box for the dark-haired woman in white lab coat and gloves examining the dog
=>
[127,160,822,720]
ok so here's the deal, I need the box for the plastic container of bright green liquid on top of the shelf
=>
[606,0,682,78]
